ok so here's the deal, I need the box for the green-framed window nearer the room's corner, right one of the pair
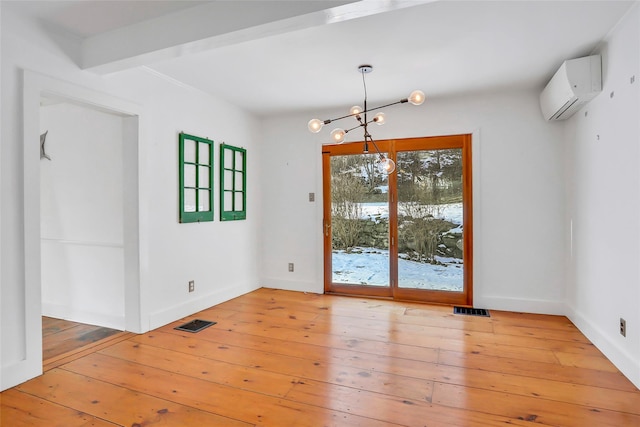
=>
[220,144,247,221]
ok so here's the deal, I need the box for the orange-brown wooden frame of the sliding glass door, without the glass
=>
[322,134,473,306]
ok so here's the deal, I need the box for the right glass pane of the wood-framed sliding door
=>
[397,149,464,292]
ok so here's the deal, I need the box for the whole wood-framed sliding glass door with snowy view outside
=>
[323,135,472,305]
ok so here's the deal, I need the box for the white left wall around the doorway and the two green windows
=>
[0,3,261,389]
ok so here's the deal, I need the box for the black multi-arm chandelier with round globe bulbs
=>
[308,65,424,175]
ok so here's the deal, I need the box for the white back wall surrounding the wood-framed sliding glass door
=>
[262,91,566,314]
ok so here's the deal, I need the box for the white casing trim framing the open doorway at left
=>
[8,70,147,388]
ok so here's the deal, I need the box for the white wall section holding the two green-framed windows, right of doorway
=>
[122,69,262,329]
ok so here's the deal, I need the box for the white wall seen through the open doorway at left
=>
[40,103,125,330]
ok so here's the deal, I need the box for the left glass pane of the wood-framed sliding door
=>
[331,154,389,286]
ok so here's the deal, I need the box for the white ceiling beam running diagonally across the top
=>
[80,0,436,74]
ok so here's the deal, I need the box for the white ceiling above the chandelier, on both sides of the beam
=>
[3,0,634,115]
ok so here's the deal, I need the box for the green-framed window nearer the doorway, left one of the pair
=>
[179,133,214,223]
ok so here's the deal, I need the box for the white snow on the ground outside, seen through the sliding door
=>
[332,203,463,292]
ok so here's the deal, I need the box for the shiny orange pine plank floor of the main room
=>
[0,289,640,427]
